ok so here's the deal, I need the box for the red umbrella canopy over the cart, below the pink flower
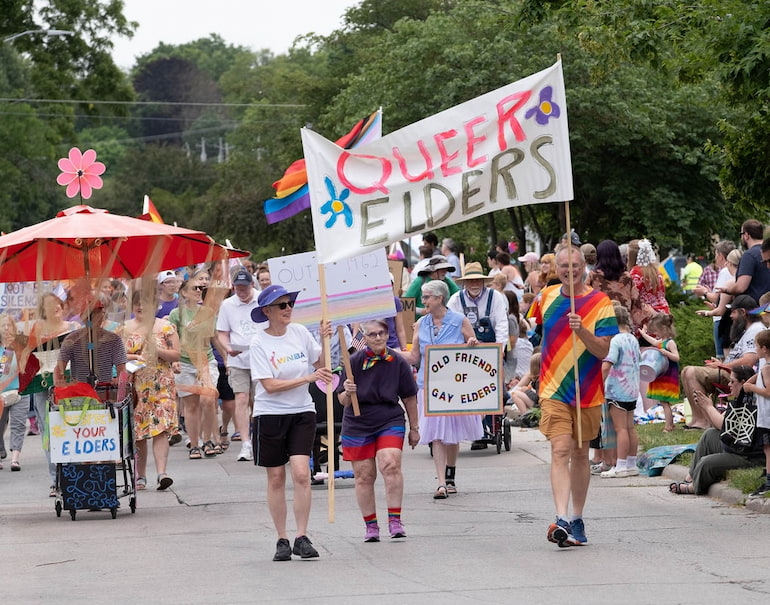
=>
[0,205,248,282]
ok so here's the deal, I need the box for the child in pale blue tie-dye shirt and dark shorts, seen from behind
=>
[601,302,642,478]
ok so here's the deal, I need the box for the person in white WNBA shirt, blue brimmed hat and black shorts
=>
[244,285,332,561]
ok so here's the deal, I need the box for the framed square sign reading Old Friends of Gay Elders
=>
[423,343,503,416]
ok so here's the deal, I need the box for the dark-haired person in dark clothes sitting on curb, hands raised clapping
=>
[668,366,765,496]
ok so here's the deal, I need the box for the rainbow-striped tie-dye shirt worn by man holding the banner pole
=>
[528,284,618,408]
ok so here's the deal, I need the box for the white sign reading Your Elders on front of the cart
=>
[48,410,121,463]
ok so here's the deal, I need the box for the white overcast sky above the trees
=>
[113,0,360,69]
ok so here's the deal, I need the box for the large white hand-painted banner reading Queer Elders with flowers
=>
[302,62,573,263]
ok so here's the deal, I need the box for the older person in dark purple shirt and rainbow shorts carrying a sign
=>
[340,320,420,542]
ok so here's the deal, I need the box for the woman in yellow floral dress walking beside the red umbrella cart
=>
[123,292,180,490]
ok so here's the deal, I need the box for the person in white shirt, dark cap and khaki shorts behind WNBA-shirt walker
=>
[217,268,258,461]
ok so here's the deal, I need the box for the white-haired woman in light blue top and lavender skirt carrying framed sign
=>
[402,280,476,500]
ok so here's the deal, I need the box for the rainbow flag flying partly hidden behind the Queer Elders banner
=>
[264,109,382,225]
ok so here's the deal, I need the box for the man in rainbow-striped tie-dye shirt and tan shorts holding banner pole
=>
[529,247,618,547]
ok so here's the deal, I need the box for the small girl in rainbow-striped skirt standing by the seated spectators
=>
[641,313,679,433]
